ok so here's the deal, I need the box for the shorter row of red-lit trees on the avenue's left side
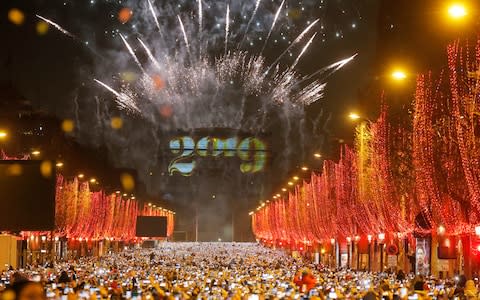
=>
[0,152,175,241]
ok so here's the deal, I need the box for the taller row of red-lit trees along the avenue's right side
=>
[252,37,480,248]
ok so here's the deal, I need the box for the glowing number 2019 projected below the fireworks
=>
[168,136,267,176]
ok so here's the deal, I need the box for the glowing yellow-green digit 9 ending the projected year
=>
[237,138,267,173]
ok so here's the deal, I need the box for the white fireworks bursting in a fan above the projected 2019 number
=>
[38,0,355,129]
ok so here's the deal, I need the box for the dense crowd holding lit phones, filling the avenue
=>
[0,243,478,300]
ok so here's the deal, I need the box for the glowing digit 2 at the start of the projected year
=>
[168,136,195,176]
